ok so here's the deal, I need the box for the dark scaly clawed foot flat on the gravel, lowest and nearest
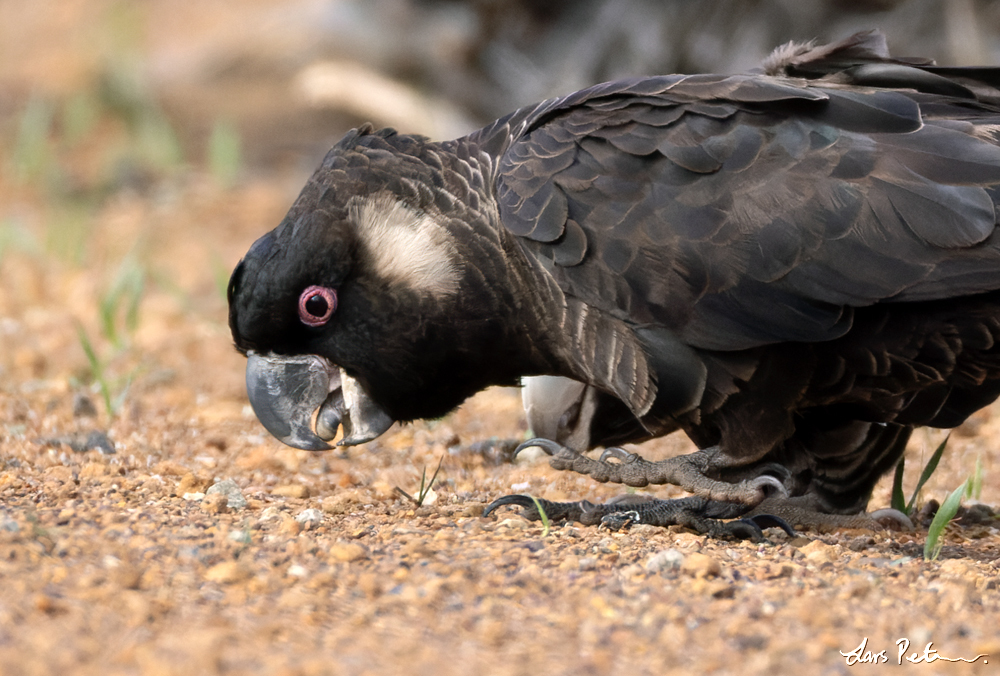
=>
[483,495,795,542]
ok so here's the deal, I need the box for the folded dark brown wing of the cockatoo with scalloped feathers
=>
[497,52,1000,368]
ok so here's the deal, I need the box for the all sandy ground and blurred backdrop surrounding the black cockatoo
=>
[0,7,1000,676]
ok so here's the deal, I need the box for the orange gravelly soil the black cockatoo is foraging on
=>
[0,2,1000,676]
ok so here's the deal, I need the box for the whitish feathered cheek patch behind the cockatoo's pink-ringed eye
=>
[350,196,459,296]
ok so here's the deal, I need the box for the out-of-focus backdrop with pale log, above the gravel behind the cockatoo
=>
[0,0,1000,200]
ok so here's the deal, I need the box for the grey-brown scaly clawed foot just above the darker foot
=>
[514,439,788,507]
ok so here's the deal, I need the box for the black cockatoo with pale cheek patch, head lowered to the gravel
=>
[230,33,1000,540]
